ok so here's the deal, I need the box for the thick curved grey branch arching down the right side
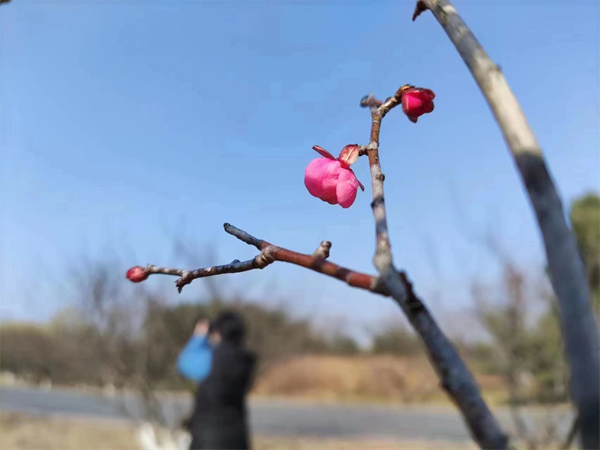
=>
[413,0,600,450]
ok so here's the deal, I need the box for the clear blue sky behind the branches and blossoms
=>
[0,0,600,338]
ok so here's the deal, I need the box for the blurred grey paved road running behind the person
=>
[0,388,569,442]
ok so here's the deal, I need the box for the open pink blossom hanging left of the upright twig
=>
[304,144,365,208]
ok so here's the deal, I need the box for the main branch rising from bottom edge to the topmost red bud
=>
[361,89,508,449]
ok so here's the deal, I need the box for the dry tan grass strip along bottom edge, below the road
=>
[0,413,476,450]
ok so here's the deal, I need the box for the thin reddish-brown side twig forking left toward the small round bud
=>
[135,223,389,296]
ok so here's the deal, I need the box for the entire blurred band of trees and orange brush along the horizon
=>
[0,194,600,412]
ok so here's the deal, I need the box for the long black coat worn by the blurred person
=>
[190,341,256,450]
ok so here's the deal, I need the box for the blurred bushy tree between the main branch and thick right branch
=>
[472,260,568,450]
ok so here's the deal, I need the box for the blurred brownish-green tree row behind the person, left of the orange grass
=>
[0,298,344,390]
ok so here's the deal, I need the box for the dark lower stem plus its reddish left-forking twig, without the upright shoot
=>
[131,216,507,449]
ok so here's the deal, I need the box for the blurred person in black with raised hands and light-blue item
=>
[177,311,256,450]
